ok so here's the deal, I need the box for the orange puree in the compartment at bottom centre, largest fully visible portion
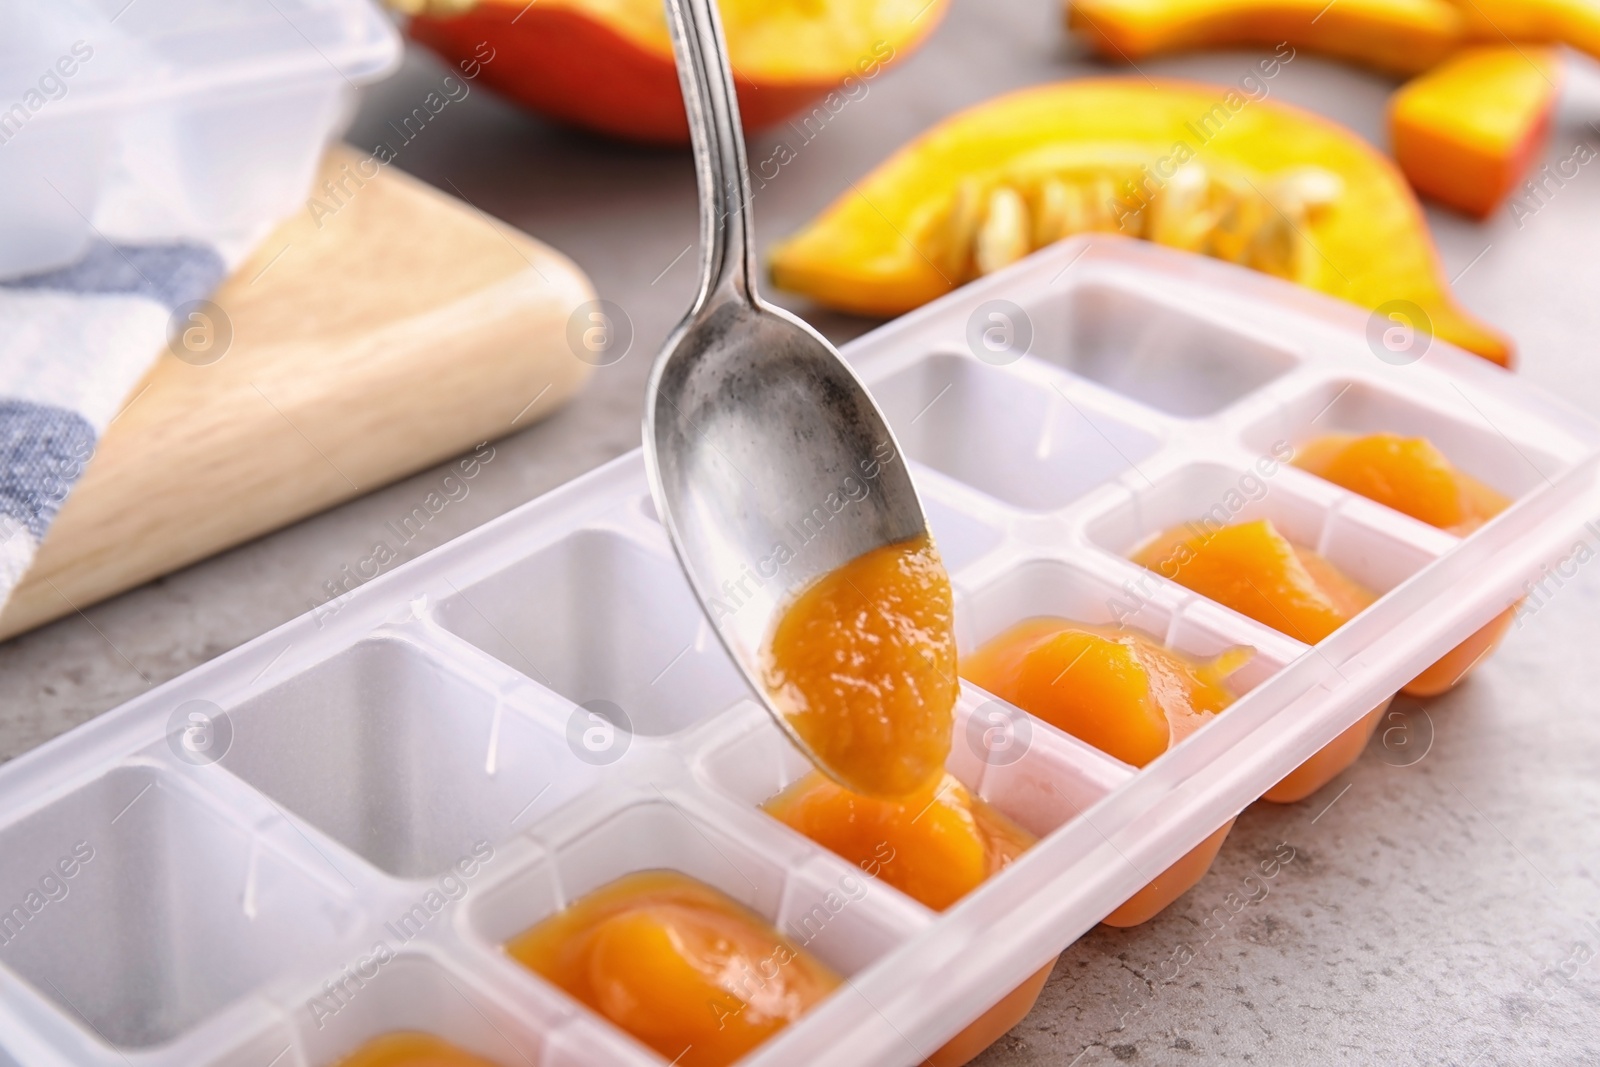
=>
[506,870,840,1067]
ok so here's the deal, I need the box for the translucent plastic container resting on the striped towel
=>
[0,0,400,278]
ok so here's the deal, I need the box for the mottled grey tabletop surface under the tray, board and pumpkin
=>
[0,0,1600,1067]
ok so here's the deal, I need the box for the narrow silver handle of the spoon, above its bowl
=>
[666,0,757,318]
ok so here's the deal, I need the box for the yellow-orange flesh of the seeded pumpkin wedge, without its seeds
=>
[771,78,1512,366]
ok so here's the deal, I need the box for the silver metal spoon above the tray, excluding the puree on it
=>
[645,0,928,769]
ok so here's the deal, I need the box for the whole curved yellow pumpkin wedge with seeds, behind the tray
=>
[771,78,1510,365]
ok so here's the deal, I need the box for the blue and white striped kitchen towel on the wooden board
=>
[0,235,240,605]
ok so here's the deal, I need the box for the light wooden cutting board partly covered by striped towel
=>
[0,147,594,638]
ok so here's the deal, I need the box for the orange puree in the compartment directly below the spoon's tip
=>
[765,773,1034,912]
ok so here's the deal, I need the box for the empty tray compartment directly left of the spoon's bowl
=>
[435,526,749,736]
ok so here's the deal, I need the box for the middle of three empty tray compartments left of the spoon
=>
[219,635,597,878]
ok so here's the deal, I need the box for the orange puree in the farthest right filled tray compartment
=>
[1294,434,1510,536]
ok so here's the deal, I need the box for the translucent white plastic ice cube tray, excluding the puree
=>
[0,238,1600,1067]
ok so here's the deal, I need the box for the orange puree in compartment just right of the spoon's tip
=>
[962,619,1253,766]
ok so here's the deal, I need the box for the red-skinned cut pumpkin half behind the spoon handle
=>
[398,0,949,144]
